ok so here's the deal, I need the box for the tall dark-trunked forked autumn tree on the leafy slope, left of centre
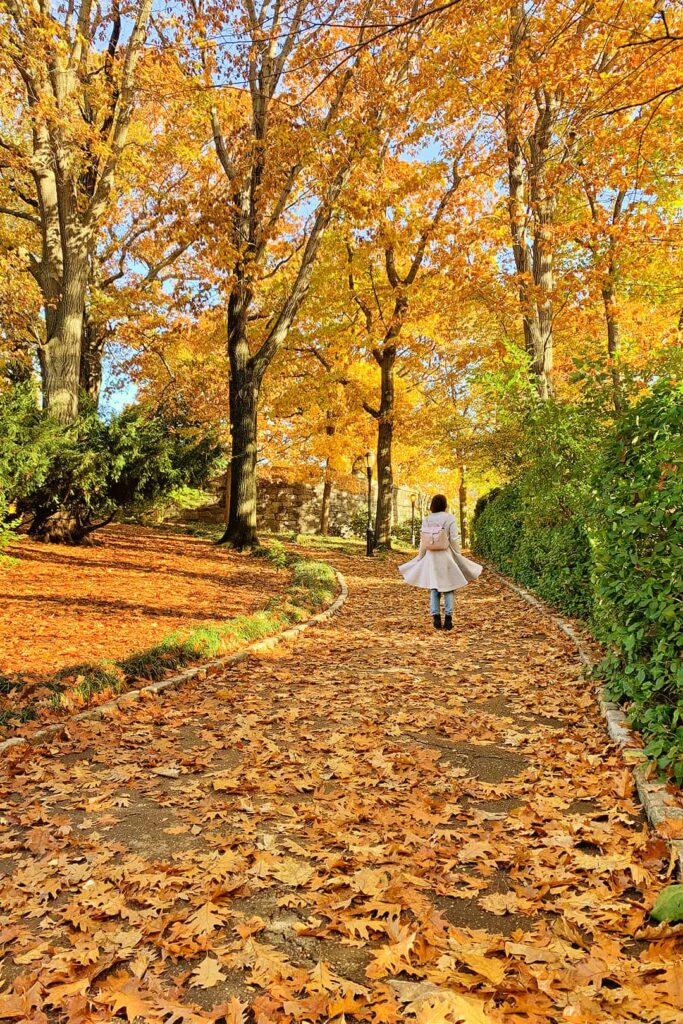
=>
[175,0,378,548]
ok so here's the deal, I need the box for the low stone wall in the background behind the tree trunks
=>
[182,468,426,536]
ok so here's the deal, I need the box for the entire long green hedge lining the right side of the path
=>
[474,381,683,783]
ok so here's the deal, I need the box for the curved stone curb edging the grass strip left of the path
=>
[0,569,348,754]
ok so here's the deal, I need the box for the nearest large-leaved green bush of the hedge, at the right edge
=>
[594,382,683,783]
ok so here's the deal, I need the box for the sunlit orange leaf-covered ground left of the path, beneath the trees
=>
[0,525,287,682]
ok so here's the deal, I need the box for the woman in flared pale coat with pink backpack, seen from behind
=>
[398,495,481,630]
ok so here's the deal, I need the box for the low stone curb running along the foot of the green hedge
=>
[486,565,683,880]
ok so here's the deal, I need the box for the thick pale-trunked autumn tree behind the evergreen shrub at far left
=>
[0,0,152,422]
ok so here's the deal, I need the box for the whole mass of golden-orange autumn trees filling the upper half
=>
[0,0,683,547]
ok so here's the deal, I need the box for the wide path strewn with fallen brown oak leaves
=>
[0,556,683,1024]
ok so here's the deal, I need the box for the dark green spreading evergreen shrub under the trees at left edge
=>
[0,385,220,544]
